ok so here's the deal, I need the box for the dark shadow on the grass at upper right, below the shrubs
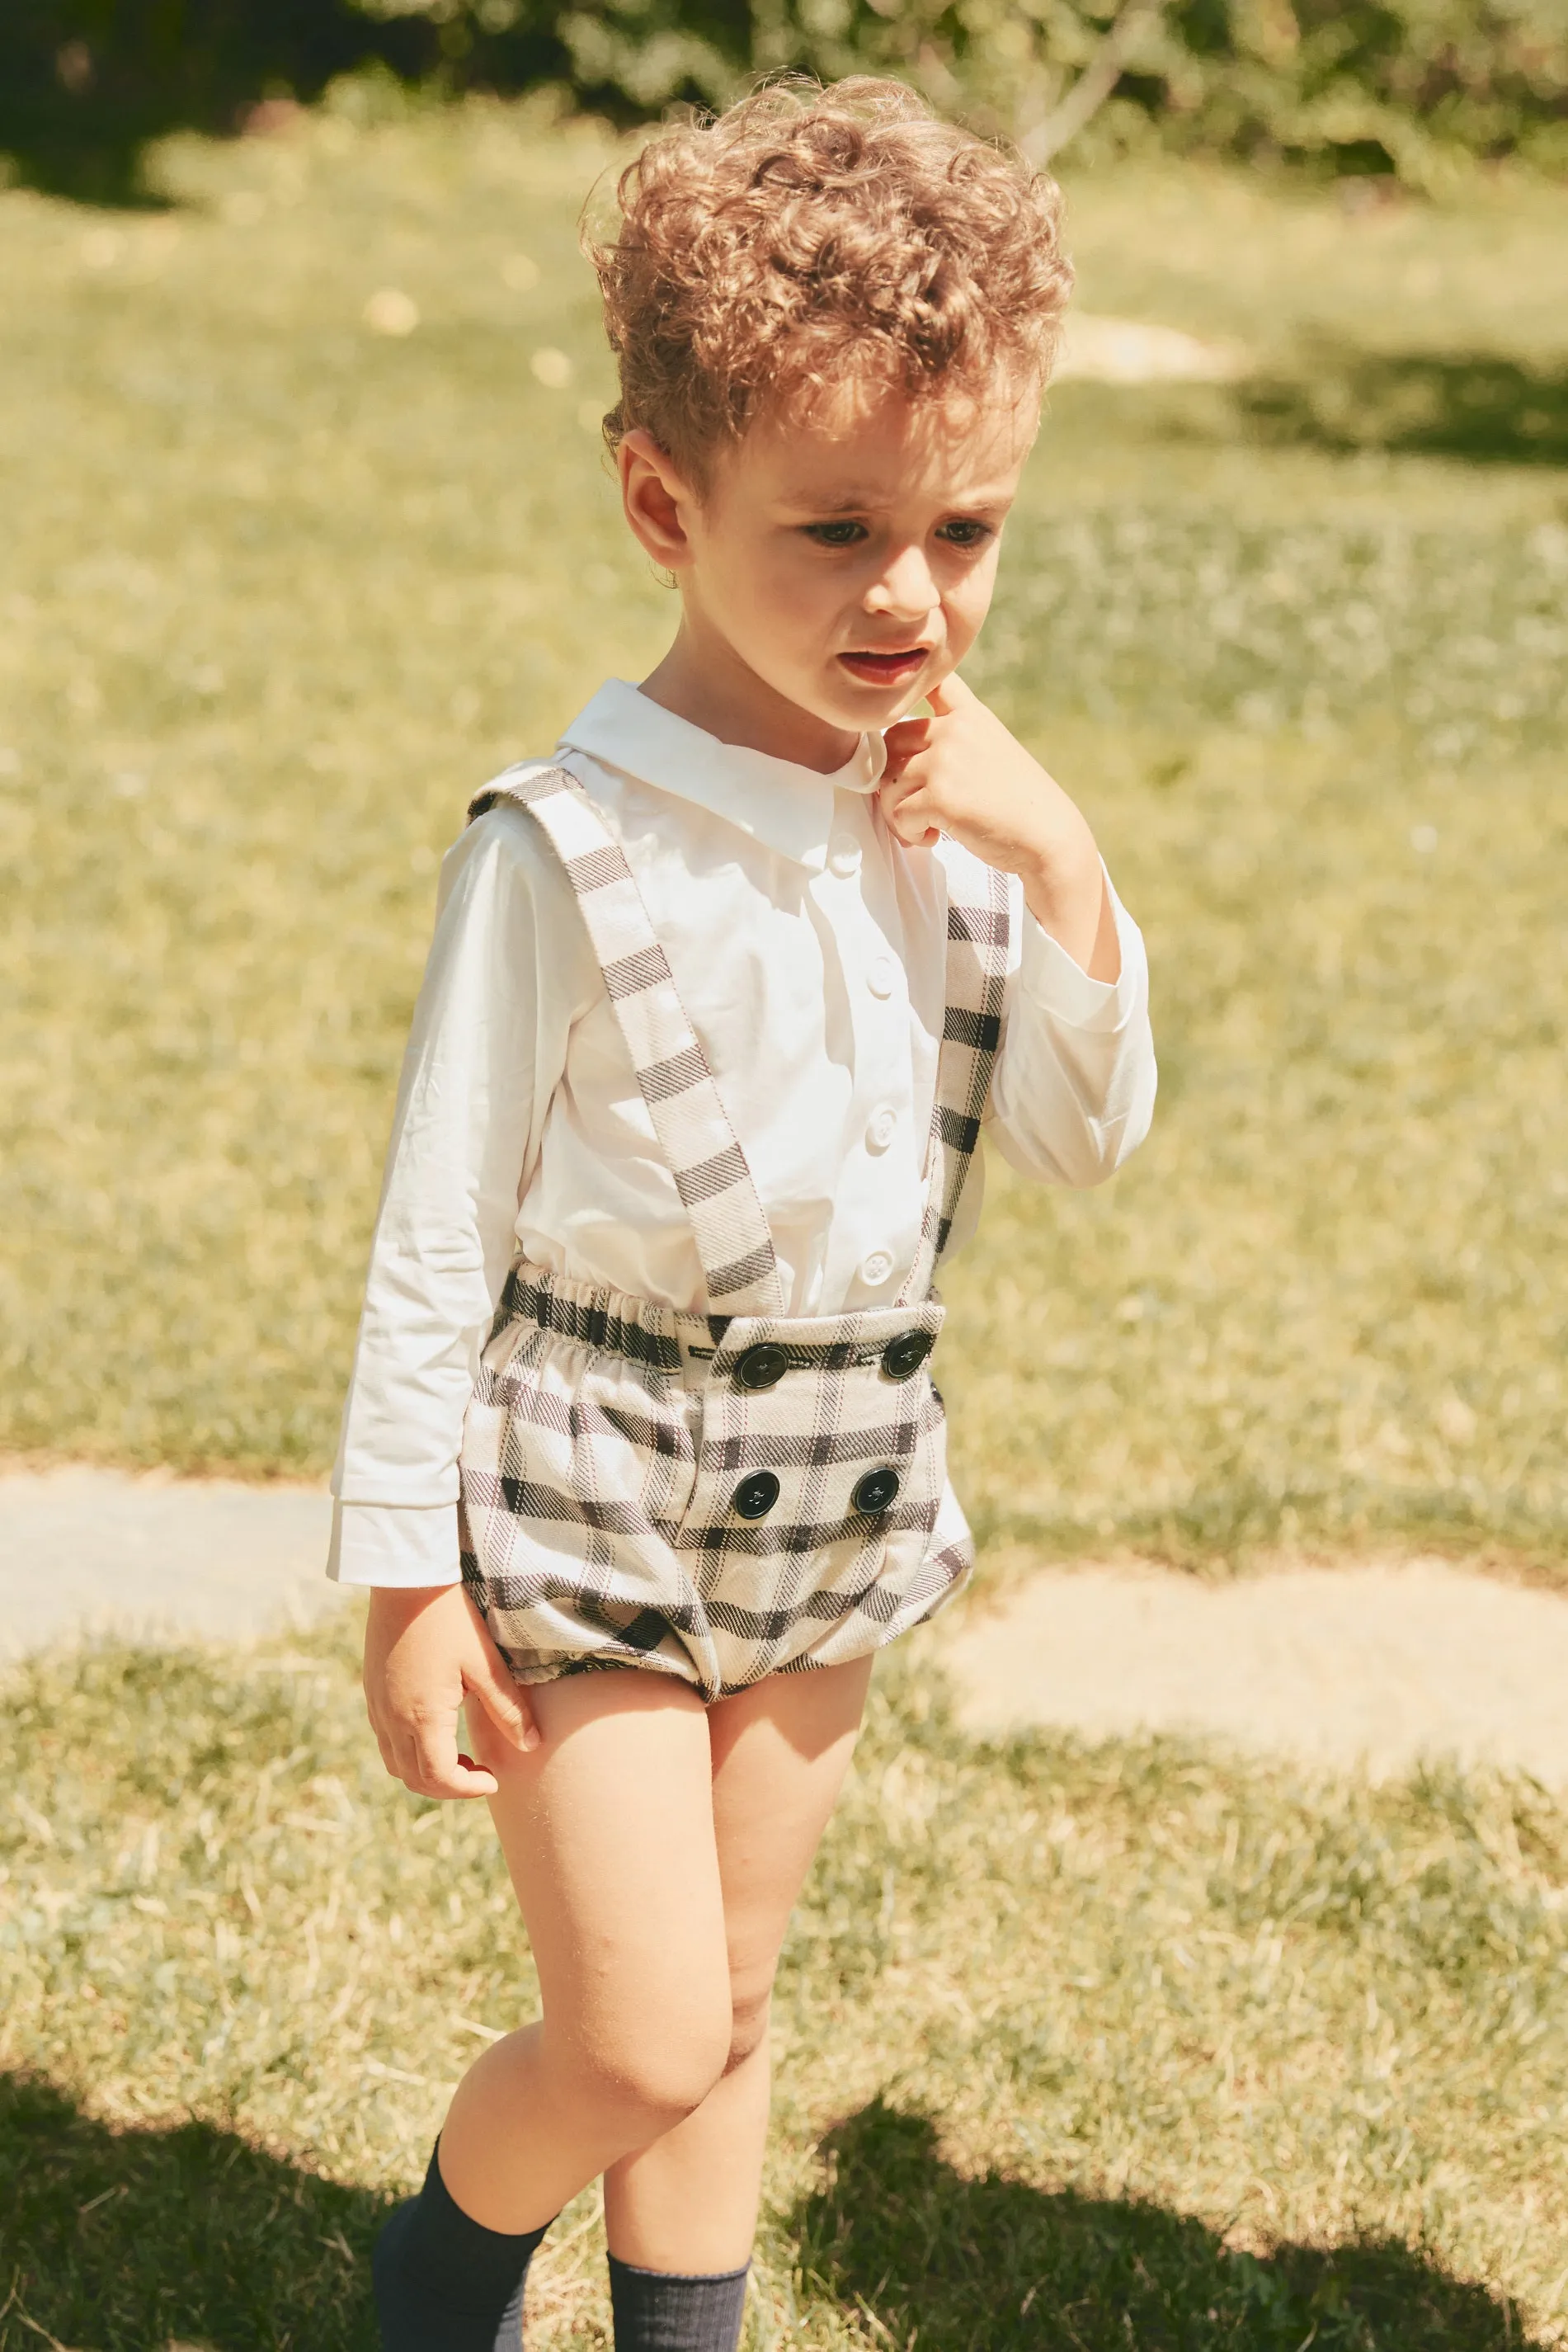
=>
[1241,348,1568,465]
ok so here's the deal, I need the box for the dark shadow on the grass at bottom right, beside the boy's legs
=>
[794,2100,1533,2352]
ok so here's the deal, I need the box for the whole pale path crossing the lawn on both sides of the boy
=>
[0,1465,1568,1788]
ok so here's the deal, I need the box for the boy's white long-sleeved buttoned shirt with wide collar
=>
[329,680,1154,1586]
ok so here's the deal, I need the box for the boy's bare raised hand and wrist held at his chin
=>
[877,675,1121,981]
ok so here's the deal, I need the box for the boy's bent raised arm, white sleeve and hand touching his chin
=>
[882,677,1156,1185]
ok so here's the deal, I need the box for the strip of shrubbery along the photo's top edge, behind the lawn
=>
[0,0,1568,193]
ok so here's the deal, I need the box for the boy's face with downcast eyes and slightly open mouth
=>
[637,376,1039,757]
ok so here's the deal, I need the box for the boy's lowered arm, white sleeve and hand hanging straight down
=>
[329,809,597,1797]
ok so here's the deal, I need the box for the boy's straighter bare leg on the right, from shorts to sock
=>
[604,1658,872,2274]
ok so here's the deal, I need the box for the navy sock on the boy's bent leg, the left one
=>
[371,2140,550,2352]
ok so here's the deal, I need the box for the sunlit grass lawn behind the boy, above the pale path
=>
[0,92,1568,1564]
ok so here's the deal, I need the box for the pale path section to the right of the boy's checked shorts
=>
[926,1559,1568,1788]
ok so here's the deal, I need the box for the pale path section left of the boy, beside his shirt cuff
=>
[0,1465,338,1658]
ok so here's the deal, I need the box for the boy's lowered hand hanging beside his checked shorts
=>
[365,1586,539,1797]
